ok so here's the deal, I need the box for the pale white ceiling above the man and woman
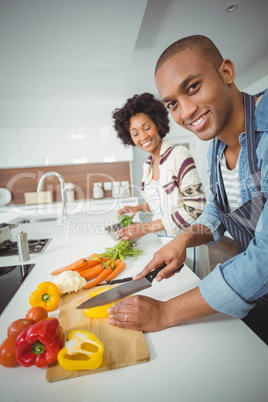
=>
[0,0,268,100]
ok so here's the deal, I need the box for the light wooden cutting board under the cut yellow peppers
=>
[46,289,150,382]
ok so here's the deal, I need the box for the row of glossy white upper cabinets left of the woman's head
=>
[0,125,133,169]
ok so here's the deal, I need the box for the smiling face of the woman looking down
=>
[129,113,162,154]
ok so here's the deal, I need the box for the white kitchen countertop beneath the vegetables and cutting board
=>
[0,204,268,402]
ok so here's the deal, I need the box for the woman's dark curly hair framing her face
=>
[112,92,169,146]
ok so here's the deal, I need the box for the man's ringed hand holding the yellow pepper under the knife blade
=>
[108,296,167,332]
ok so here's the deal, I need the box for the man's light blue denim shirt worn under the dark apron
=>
[195,90,268,318]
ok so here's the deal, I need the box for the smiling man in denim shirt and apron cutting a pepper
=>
[109,35,268,344]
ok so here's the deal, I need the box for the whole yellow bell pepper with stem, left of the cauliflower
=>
[29,282,60,311]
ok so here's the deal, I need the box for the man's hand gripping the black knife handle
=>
[133,237,186,282]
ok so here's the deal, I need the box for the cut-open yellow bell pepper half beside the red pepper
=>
[58,330,104,370]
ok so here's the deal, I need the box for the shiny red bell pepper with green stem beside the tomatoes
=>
[15,318,64,367]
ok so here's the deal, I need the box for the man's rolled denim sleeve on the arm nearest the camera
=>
[200,198,268,318]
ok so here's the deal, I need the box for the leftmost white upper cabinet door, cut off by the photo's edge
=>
[0,128,22,168]
